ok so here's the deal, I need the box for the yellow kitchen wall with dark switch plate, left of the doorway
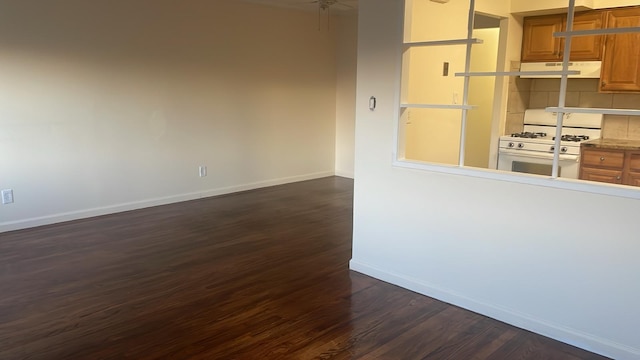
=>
[401,0,468,164]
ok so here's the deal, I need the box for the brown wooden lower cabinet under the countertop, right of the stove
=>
[580,148,640,186]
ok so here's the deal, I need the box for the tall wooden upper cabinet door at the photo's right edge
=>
[600,7,640,91]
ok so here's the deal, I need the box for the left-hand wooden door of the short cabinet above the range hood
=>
[522,15,564,61]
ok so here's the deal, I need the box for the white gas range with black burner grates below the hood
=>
[498,109,602,179]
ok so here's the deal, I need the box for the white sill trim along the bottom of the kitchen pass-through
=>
[392,159,640,200]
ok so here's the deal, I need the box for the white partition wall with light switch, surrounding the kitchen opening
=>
[351,0,640,359]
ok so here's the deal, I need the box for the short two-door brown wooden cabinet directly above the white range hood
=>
[522,11,605,62]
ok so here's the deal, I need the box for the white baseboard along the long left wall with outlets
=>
[0,171,335,233]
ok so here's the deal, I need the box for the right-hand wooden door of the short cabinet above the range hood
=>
[560,11,605,61]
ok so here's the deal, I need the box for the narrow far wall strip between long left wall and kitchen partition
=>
[335,11,358,178]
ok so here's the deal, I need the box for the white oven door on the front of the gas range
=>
[498,148,580,179]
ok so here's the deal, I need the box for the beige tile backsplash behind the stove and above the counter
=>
[505,71,640,140]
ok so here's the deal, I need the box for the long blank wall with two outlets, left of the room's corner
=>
[0,0,353,232]
